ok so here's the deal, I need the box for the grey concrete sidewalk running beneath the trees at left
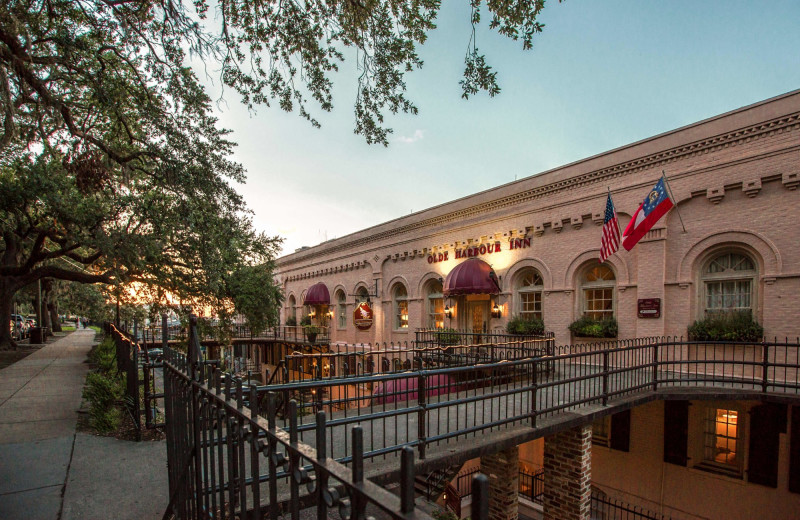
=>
[0,330,167,520]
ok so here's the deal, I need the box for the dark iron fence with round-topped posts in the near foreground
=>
[164,316,488,520]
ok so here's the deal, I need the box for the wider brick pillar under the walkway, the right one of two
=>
[542,425,592,520]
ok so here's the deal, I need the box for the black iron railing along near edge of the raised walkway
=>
[245,338,800,466]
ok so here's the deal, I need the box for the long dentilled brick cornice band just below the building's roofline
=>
[278,112,800,264]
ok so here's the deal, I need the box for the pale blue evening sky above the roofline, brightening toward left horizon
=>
[192,0,800,254]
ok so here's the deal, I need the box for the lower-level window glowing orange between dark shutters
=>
[703,408,742,474]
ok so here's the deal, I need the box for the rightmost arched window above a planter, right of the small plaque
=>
[701,252,758,316]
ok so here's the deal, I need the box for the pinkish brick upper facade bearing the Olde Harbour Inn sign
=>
[277,91,800,344]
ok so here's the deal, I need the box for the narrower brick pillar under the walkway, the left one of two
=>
[481,446,519,520]
